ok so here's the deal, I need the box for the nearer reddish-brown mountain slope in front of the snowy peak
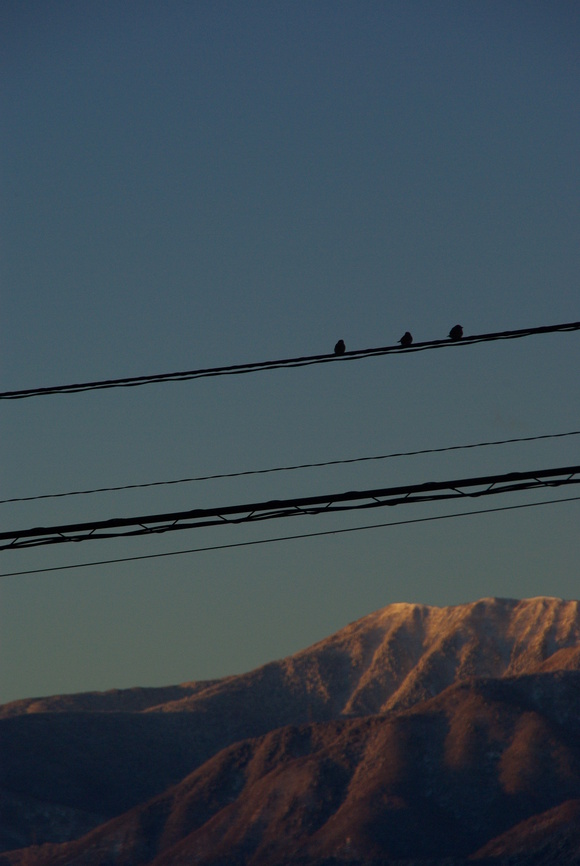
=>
[9,671,580,866]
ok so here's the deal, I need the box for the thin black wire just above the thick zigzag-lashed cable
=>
[0,430,580,505]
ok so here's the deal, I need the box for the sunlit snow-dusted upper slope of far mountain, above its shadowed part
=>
[0,597,580,726]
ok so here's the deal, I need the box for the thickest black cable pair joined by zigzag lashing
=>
[0,466,580,550]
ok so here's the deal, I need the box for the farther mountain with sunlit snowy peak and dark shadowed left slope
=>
[0,598,580,862]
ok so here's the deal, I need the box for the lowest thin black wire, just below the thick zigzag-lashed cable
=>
[0,496,580,577]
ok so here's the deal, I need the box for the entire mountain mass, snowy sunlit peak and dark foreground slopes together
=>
[0,598,580,866]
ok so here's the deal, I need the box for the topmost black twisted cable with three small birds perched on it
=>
[0,322,580,400]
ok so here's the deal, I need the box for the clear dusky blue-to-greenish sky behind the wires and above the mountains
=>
[0,0,580,702]
